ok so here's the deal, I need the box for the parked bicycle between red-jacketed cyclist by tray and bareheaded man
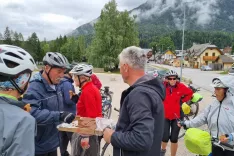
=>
[100,86,113,119]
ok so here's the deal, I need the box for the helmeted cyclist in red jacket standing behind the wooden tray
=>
[70,64,102,156]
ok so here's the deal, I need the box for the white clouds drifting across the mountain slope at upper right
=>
[132,0,220,26]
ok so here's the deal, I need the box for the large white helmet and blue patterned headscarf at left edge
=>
[0,44,37,94]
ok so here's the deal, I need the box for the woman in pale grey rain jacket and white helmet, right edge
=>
[178,75,234,156]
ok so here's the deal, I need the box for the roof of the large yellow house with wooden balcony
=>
[187,43,222,56]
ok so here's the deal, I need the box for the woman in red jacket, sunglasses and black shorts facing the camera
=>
[161,70,193,156]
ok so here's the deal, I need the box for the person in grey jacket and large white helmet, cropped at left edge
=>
[0,45,37,156]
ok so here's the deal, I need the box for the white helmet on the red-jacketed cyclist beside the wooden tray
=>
[70,64,93,77]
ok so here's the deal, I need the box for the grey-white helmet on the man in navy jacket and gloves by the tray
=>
[43,52,70,68]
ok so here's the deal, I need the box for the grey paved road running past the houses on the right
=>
[150,63,221,92]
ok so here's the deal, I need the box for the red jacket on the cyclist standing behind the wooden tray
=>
[76,81,102,118]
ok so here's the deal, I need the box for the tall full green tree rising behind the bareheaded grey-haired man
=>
[88,0,139,68]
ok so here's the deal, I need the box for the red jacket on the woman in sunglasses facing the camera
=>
[163,82,193,120]
